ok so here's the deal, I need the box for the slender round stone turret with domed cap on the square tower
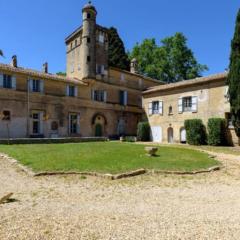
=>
[81,1,97,79]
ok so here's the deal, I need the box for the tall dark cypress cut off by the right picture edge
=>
[228,10,240,137]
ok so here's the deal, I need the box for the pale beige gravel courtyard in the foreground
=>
[0,149,240,240]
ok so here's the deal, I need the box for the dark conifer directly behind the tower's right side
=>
[108,27,130,70]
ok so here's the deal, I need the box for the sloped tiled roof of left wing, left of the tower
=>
[0,63,87,85]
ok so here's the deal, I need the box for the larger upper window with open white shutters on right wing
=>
[178,96,198,113]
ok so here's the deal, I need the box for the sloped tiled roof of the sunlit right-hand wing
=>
[143,72,228,94]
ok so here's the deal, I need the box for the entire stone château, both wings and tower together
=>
[0,3,238,143]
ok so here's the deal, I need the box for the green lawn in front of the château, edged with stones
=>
[0,142,219,173]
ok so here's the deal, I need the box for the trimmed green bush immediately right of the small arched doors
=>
[184,119,206,145]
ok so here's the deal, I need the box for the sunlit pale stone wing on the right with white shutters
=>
[143,72,238,145]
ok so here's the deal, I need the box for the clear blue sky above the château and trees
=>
[0,0,240,75]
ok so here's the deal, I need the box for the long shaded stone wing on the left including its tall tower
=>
[0,1,161,138]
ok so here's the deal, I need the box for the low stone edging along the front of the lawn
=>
[0,153,223,180]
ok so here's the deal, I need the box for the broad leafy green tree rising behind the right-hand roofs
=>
[130,33,208,83]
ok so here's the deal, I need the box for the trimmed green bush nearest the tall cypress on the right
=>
[208,118,226,146]
